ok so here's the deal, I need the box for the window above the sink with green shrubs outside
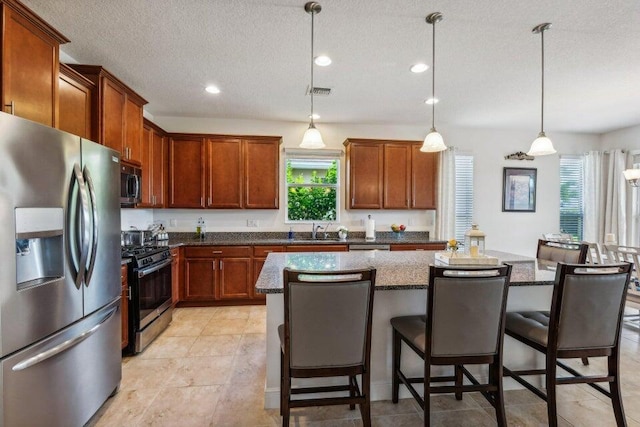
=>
[285,151,340,222]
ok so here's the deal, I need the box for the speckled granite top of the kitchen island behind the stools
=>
[256,251,556,294]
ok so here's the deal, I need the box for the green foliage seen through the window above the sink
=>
[286,160,338,221]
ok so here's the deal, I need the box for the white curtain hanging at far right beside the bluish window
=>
[584,149,635,245]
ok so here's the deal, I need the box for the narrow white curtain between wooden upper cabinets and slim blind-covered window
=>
[435,147,457,240]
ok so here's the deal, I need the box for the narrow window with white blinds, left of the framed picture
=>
[455,154,473,242]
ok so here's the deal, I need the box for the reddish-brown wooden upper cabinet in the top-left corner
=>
[0,0,69,127]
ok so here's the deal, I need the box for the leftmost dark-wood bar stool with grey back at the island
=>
[278,268,376,426]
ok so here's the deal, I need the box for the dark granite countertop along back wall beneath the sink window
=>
[166,232,446,247]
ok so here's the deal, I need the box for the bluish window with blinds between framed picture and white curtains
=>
[560,156,584,240]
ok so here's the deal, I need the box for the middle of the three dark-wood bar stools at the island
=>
[391,265,511,426]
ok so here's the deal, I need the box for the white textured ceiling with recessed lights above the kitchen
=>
[23,0,640,133]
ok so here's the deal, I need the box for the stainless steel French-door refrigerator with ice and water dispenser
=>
[0,113,122,426]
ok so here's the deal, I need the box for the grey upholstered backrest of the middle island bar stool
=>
[426,265,511,357]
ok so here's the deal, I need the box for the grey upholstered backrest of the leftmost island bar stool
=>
[284,269,375,369]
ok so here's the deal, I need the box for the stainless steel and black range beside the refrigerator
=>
[122,246,173,353]
